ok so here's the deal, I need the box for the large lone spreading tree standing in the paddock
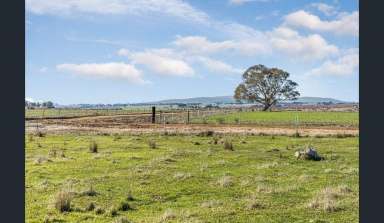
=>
[234,64,300,111]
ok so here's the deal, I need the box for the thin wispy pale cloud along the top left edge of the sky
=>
[26,0,208,23]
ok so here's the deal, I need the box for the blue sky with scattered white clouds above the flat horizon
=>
[25,0,359,104]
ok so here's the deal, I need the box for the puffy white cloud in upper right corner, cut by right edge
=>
[284,10,359,36]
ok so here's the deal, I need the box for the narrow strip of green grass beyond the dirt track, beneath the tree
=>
[192,111,359,127]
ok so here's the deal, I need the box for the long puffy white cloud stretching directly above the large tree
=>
[173,27,338,60]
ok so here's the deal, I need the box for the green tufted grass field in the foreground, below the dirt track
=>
[25,135,359,223]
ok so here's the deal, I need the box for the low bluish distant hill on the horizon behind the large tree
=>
[142,96,347,104]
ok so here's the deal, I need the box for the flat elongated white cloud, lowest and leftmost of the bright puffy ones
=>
[56,62,147,84]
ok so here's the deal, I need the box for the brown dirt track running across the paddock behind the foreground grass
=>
[26,123,359,136]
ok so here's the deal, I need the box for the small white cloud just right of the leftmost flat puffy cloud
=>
[127,49,194,77]
